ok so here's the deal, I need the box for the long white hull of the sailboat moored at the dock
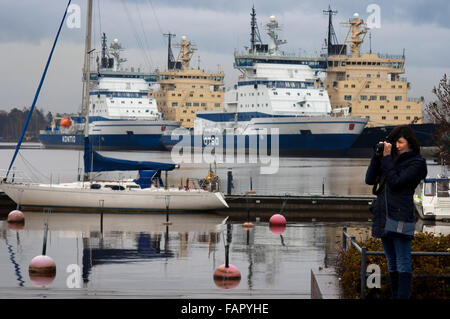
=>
[0,182,228,211]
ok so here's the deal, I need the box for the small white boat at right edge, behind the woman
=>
[414,177,450,221]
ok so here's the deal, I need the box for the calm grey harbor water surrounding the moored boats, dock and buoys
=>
[0,148,447,299]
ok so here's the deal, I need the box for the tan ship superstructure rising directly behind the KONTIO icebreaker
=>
[154,37,225,128]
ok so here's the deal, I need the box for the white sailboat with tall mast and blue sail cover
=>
[0,0,228,215]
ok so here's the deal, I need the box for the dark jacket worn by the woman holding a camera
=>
[366,151,427,238]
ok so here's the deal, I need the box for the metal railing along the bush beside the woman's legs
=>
[342,227,450,299]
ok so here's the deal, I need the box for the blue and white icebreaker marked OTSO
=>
[164,9,367,153]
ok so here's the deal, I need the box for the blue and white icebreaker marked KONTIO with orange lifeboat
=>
[39,34,180,150]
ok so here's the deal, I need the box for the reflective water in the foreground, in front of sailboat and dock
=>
[0,212,380,298]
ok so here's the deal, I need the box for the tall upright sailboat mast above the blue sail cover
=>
[83,0,92,137]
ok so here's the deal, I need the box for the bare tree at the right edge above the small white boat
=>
[425,74,450,165]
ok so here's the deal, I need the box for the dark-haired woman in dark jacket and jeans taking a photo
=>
[366,125,427,299]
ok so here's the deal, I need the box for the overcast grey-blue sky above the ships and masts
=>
[0,0,450,113]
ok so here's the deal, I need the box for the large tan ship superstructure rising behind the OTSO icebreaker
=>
[325,14,423,127]
